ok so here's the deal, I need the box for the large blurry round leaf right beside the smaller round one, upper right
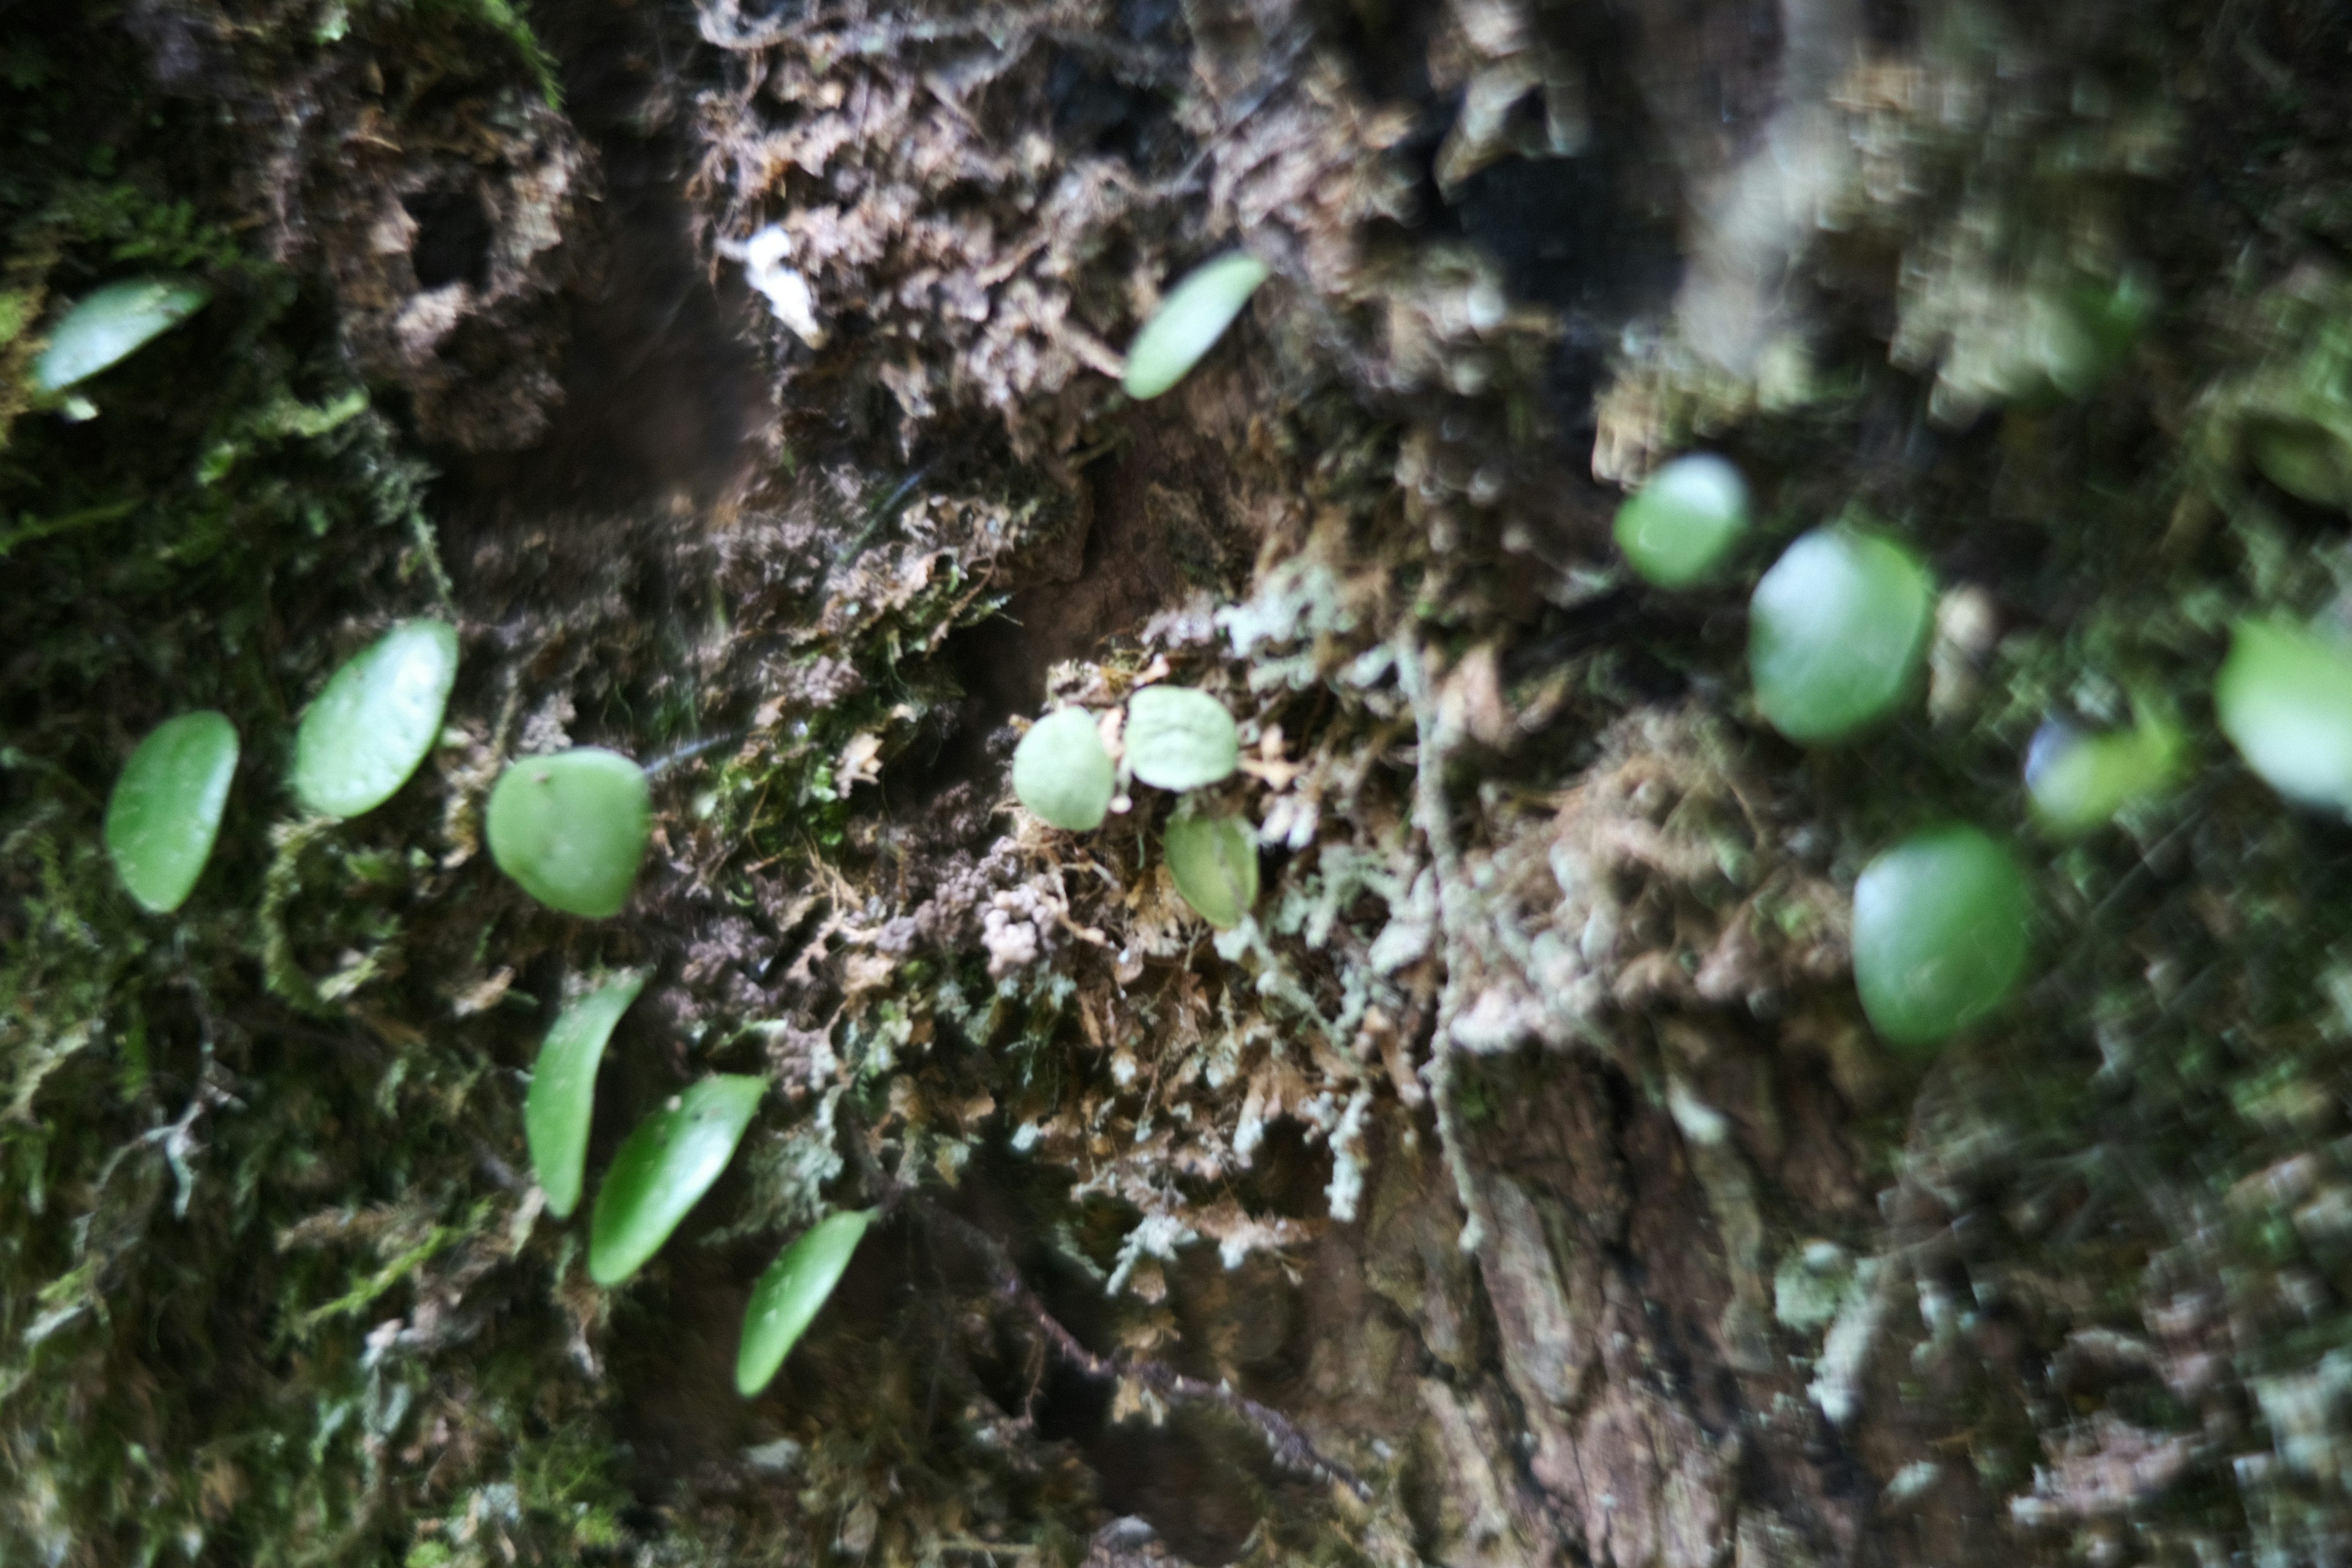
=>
[1747,527,1936,745]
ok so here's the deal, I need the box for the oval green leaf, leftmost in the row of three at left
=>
[106,707,238,914]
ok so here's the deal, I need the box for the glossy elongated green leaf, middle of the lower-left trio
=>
[588,1074,767,1286]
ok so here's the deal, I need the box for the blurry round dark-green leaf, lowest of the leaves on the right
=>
[1853,825,2035,1046]
